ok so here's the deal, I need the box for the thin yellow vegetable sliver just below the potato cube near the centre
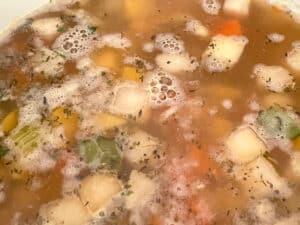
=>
[95,113,127,130]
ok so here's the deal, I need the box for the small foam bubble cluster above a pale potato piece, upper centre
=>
[155,33,185,53]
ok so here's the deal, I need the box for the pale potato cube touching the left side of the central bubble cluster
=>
[109,81,147,119]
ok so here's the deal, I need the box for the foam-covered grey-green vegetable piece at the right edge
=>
[256,105,300,139]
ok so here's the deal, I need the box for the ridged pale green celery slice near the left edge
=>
[12,126,40,154]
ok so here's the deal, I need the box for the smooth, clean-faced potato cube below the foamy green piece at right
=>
[226,127,267,164]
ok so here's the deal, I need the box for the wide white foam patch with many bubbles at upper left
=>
[52,25,98,59]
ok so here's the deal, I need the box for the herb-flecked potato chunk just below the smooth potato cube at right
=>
[235,156,292,198]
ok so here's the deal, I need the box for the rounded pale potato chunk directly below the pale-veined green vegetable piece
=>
[79,174,122,212]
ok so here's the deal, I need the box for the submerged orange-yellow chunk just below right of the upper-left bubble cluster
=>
[92,48,122,72]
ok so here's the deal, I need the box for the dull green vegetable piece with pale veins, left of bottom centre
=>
[76,137,121,170]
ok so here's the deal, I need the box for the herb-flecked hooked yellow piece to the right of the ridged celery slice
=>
[50,107,79,141]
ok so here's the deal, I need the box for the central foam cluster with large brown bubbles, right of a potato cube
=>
[144,70,185,107]
